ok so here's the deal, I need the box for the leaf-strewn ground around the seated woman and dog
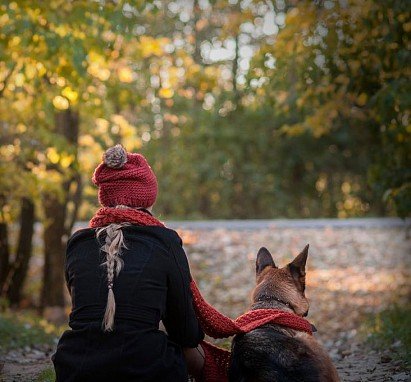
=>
[0,223,411,382]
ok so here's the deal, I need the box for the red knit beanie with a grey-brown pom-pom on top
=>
[93,145,157,208]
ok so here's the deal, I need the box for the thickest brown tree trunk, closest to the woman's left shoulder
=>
[41,109,80,310]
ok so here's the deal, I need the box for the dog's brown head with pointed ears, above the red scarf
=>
[252,245,309,317]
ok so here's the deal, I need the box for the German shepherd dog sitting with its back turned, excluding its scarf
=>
[229,245,339,382]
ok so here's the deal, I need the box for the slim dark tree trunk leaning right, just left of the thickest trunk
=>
[7,198,35,305]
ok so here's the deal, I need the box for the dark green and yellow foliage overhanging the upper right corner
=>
[249,0,411,217]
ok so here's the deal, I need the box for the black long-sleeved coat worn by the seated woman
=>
[52,225,204,382]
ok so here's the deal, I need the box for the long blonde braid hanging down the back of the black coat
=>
[97,223,129,332]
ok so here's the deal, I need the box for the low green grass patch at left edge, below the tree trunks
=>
[0,310,65,352]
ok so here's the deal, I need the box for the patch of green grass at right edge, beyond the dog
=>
[362,304,411,367]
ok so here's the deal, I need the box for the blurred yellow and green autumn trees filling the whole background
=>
[0,0,411,380]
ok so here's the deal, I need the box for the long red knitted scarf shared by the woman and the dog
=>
[90,207,312,382]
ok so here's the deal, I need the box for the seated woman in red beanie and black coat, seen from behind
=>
[52,145,204,382]
